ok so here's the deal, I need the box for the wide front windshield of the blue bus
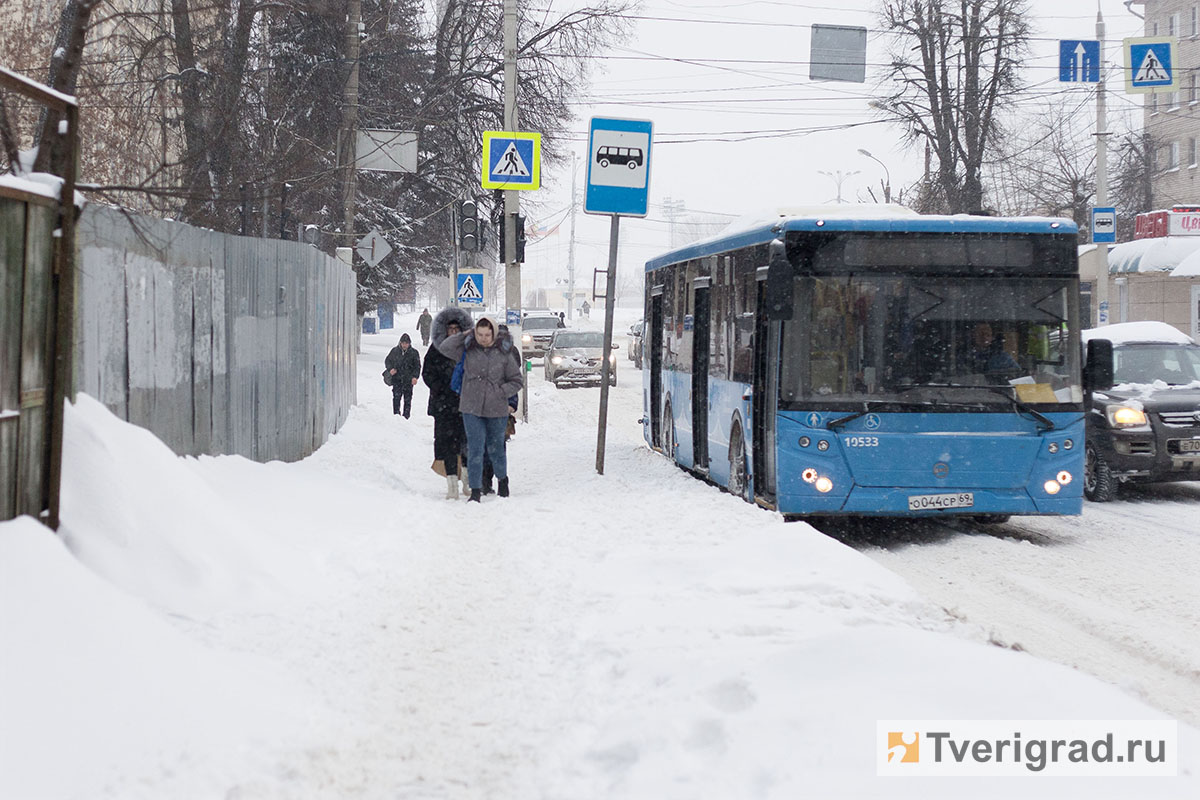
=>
[780,273,1082,409]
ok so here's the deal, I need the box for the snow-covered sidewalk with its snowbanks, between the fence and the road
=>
[0,324,1200,800]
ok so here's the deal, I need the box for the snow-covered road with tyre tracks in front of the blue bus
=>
[829,482,1200,724]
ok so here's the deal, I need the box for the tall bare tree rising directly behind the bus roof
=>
[877,0,1030,213]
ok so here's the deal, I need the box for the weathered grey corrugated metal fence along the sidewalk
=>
[76,205,358,462]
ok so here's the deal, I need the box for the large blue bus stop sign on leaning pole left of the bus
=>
[583,116,654,217]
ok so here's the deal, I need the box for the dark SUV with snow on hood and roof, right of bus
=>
[1084,321,1200,503]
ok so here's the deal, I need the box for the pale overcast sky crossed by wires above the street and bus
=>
[511,0,1142,303]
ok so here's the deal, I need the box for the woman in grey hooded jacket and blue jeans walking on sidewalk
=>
[438,317,521,503]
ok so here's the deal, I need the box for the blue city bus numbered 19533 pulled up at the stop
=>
[642,206,1085,522]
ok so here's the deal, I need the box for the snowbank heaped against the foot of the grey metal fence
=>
[61,395,313,615]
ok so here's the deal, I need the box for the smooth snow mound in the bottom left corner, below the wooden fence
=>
[0,517,313,799]
